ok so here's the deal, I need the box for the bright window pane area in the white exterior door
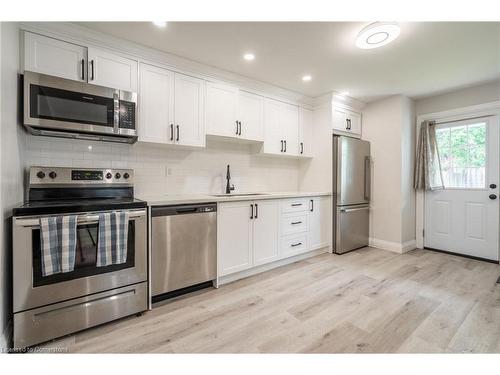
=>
[436,122,487,189]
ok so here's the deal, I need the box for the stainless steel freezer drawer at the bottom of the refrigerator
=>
[333,205,370,254]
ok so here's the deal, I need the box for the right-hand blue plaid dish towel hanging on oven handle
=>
[97,211,128,267]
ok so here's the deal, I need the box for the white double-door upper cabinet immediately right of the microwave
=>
[138,64,205,147]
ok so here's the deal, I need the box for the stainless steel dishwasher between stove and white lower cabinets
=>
[151,203,217,302]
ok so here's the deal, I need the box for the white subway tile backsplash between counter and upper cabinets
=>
[25,135,299,195]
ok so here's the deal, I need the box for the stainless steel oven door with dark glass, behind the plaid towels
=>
[13,209,147,312]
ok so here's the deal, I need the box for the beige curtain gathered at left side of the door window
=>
[413,121,444,190]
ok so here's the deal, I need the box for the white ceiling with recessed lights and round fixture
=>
[80,22,500,102]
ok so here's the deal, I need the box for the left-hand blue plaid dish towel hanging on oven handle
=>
[40,216,77,276]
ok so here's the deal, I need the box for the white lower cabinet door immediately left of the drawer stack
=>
[253,200,279,266]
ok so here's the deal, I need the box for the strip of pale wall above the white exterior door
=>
[415,80,500,116]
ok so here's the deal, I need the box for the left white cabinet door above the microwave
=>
[24,32,87,81]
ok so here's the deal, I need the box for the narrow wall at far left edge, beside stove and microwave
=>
[0,22,25,347]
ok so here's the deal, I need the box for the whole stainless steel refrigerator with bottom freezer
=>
[332,135,371,254]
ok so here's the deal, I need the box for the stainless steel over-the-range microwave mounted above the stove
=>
[23,71,137,143]
